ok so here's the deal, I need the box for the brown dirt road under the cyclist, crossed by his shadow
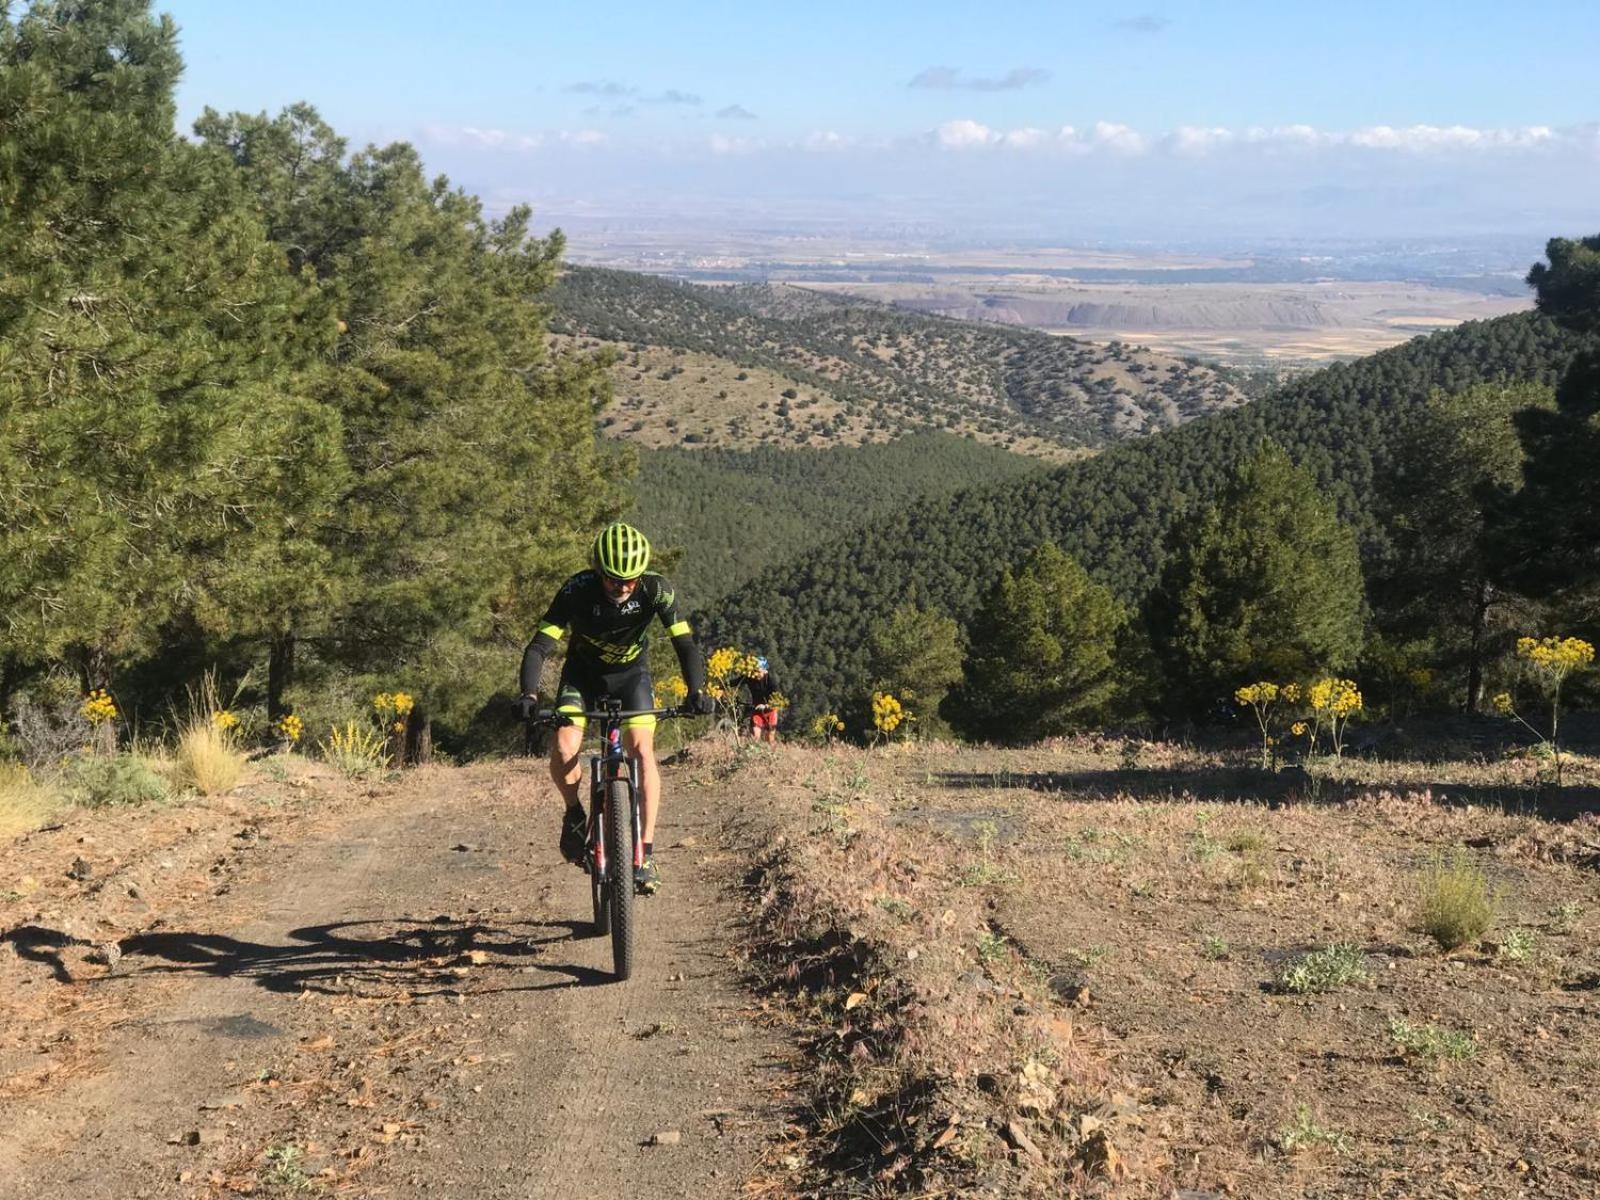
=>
[0,766,790,1200]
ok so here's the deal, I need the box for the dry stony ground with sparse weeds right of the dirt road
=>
[722,739,1600,1200]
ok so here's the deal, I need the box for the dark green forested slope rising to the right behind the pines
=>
[707,315,1579,720]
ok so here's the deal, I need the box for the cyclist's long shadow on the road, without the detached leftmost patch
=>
[104,917,611,997]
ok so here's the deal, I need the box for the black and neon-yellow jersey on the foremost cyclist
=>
[522,571,706,723]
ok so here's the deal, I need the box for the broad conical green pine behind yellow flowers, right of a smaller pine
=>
[1147,443,1365,714]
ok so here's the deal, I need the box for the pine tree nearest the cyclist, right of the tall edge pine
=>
[197,106,629,739]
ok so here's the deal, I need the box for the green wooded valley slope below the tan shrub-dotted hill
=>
[634,434,1046,606]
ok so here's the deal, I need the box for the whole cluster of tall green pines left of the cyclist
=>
[0,0,626,752]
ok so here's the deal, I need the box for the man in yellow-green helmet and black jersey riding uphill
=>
[522,522,715,891]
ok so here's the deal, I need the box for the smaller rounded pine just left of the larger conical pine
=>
[952,542,1126,742]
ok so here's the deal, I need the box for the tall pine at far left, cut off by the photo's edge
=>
[0,0,338,685]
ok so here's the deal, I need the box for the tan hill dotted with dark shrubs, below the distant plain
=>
[552,267,1250,458]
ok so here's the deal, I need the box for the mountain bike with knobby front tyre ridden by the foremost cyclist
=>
[530,696,678,981]
